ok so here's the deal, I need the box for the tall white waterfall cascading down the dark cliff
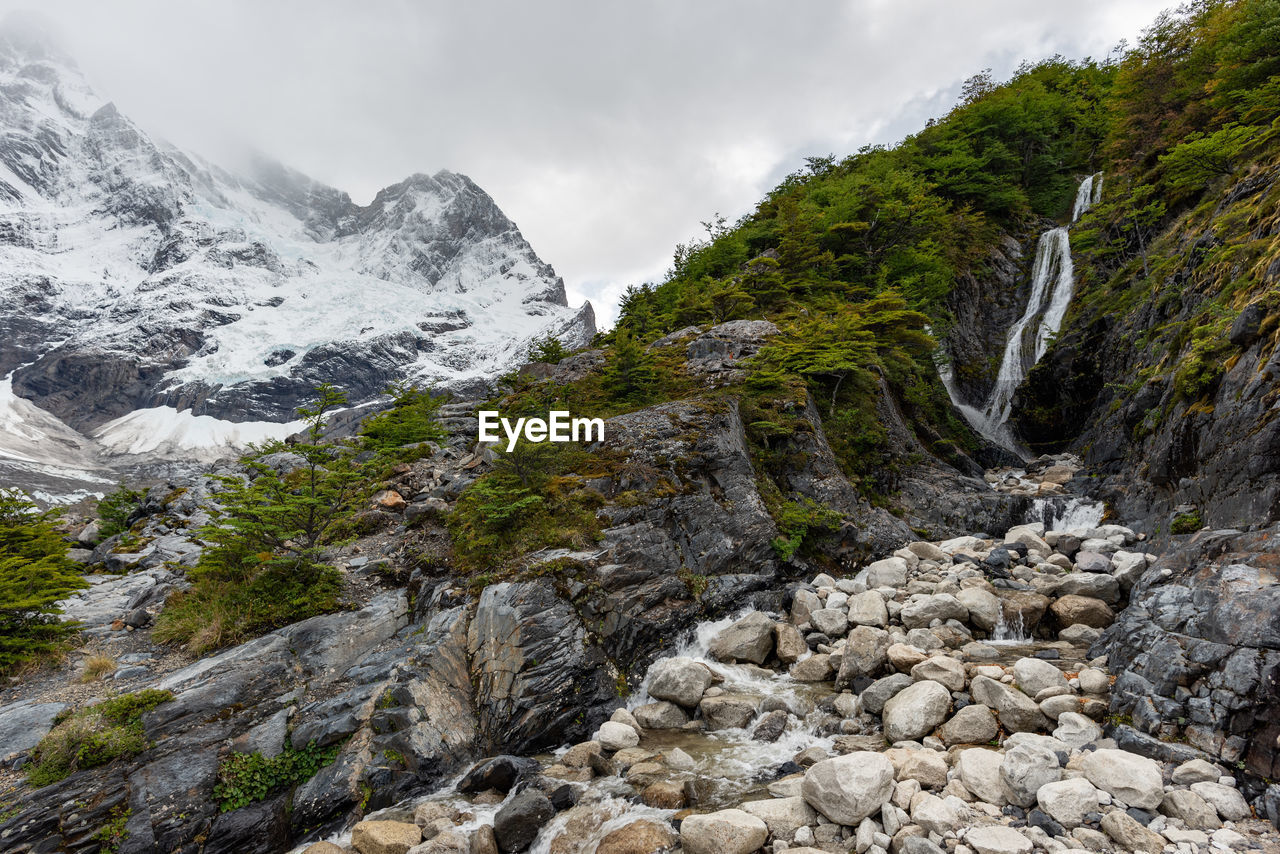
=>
[938,172,1102,453]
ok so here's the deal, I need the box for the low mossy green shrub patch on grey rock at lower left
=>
[27,689,173,789]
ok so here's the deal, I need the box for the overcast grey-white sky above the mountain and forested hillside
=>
[0,0,1170,324]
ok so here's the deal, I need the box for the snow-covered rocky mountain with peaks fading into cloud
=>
[0,20,595,501]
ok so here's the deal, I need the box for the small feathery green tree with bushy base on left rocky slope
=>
[154,385,366,654]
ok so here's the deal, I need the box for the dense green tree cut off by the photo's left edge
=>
[0,489,88,671]
